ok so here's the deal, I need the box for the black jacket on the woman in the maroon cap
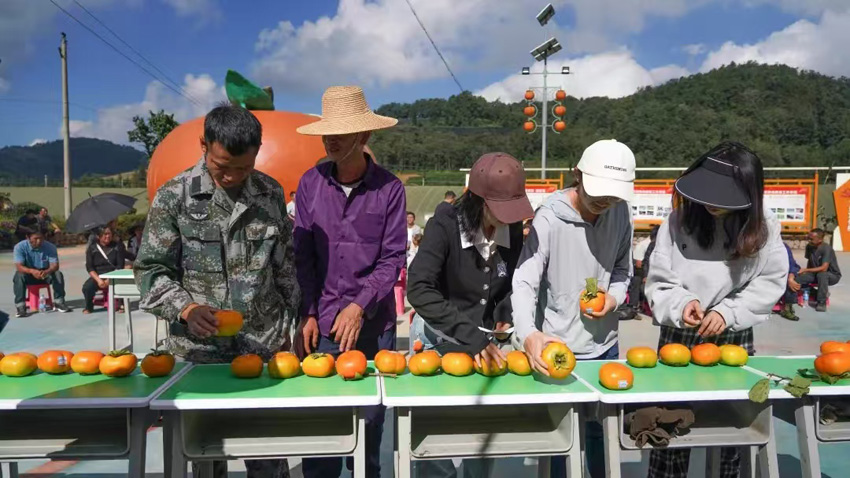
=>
[407,210,522,355]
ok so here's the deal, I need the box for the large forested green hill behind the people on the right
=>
[371,63,850,171]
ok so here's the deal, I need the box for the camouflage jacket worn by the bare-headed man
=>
[134,158,301,363]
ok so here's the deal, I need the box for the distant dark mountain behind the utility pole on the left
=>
[0,138,146,184]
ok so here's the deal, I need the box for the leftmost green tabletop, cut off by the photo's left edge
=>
[0,362,189,410]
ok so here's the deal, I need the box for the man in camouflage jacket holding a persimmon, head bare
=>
[134,106,300,478]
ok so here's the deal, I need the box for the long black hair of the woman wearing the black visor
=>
[673,141,768,259]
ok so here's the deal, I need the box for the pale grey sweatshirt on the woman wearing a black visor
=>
[646,209,788,332]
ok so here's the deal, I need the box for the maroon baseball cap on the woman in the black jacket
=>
[469,153,534,224]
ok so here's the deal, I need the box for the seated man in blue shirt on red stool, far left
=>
[12,230,71,317]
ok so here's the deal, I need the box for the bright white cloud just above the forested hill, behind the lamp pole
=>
[475,50,689,103]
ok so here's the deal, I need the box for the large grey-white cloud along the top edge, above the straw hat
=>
[252,0,712,93]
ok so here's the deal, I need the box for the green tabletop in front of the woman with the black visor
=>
[574,360,762,403]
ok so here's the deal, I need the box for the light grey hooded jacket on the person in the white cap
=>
[511,189,632,358]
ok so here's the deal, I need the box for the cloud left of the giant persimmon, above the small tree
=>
[66,74,225,144]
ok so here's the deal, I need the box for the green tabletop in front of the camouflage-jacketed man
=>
[151,364,381,410]
